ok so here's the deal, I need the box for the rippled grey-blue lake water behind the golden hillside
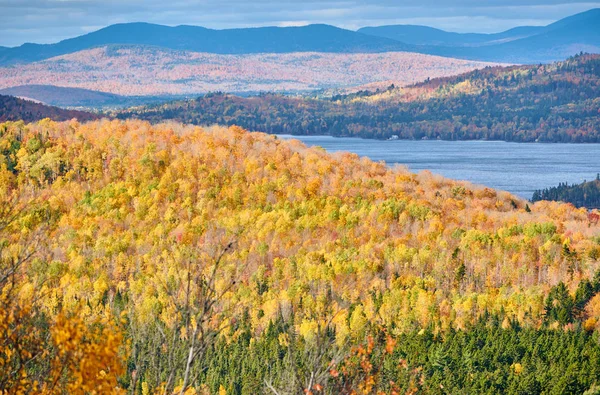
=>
[279,135,600,199]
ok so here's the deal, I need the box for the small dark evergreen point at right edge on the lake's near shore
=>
[532,174,600,209]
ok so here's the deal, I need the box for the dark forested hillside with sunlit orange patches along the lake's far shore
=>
[118,55,600,142]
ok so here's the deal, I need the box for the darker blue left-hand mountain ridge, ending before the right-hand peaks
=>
[0,23,411,65]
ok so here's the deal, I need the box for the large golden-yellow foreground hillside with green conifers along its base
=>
[0,120,600,394]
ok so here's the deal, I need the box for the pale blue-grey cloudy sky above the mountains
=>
[0,0,600,46]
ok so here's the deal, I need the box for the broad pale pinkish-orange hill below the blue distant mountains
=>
[0,45,489,96]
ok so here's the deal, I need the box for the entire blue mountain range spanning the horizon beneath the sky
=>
[0,9,600,66]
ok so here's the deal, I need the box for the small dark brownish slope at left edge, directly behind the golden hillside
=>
[0,95,100,122]
